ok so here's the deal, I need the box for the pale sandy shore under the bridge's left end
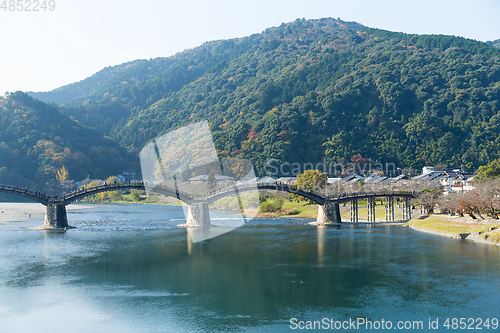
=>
[0,202,93,223]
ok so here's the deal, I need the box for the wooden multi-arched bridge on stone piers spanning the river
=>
[0,182,415,228]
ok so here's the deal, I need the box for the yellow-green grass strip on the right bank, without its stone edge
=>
[407,215,500,243]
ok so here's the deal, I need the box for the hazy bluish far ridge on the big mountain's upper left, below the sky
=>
[28,38,272,108]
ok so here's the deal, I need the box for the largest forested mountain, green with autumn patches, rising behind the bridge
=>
[29,19,500,174]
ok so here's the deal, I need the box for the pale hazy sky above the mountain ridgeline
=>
[0,0,500,95]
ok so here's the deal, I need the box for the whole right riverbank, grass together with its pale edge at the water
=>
[406,214,500,246]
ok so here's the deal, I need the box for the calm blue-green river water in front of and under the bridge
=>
[0,205,500,332]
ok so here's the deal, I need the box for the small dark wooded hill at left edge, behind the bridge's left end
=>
[0,92,133,193]
